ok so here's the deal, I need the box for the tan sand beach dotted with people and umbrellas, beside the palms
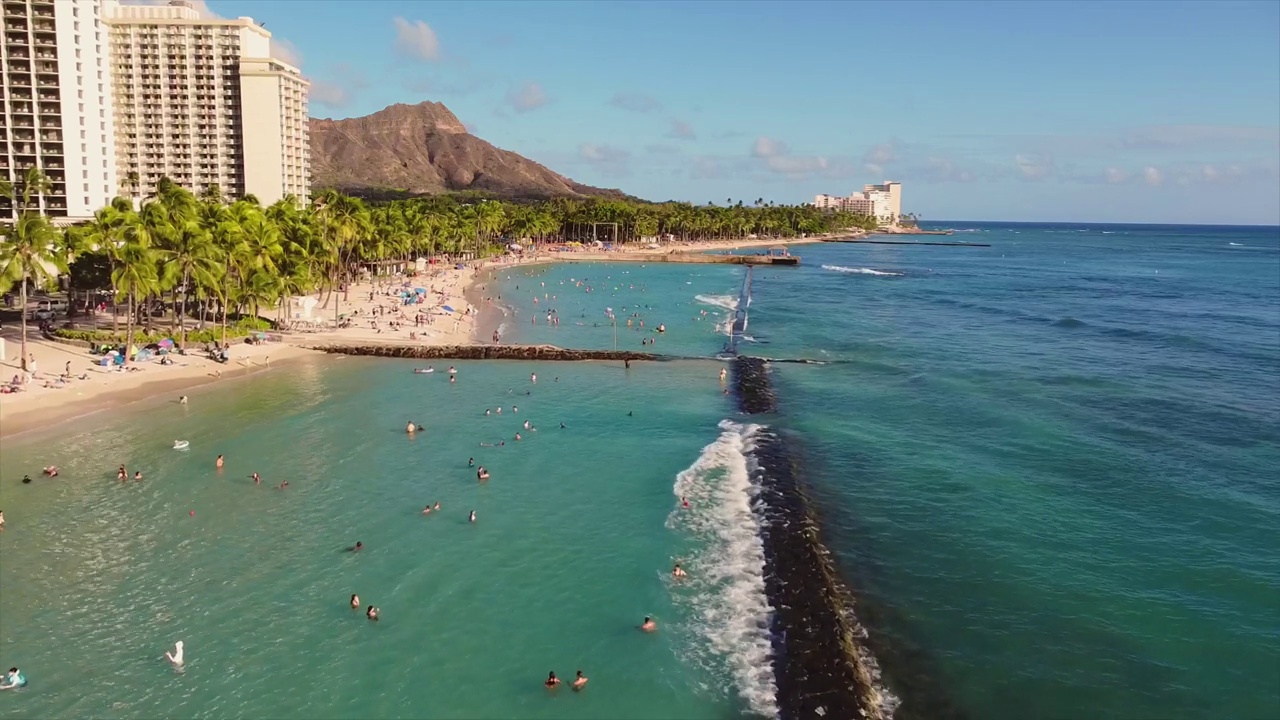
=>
[0,238,820,438]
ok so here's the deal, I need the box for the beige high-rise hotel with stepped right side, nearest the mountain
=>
[102,0,311,205]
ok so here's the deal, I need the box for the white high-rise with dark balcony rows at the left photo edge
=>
[0,0,116,224]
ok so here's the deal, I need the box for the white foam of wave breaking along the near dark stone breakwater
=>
[667,420,778,717]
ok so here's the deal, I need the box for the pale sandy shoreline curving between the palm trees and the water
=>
[0,233,834,441]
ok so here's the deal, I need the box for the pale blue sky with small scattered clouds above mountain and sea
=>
[209,0,1280,224]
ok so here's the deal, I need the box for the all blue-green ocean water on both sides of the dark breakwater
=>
[0,224,1280,719]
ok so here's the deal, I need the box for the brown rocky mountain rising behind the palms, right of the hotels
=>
[304,102,622,197]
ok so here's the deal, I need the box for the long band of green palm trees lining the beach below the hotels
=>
[0,169,874,366]
